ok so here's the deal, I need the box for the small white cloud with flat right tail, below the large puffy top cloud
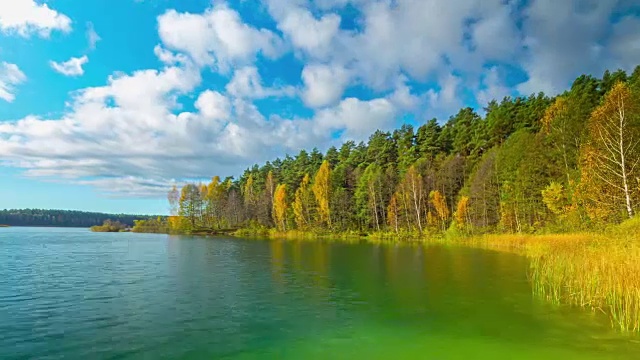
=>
[226,66,295,99]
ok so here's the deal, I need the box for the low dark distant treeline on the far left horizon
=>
[0,209,158,227]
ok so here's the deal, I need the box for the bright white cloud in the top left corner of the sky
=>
[0,0,71,37]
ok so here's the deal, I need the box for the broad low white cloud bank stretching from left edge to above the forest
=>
[0,61,397,196]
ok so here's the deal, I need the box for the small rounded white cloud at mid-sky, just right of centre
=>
[302,64,349,108]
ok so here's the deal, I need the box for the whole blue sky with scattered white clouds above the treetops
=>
[0,0,640,214]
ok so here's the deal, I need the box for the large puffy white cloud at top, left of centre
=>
[158,3,282,71]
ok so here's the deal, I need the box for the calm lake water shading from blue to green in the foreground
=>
[0,228,640,360]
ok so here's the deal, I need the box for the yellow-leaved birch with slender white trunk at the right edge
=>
[582,83,640,218]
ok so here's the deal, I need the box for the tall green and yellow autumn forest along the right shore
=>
[168,66,640,234]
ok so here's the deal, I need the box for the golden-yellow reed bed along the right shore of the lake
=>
[460,228,640,332]
